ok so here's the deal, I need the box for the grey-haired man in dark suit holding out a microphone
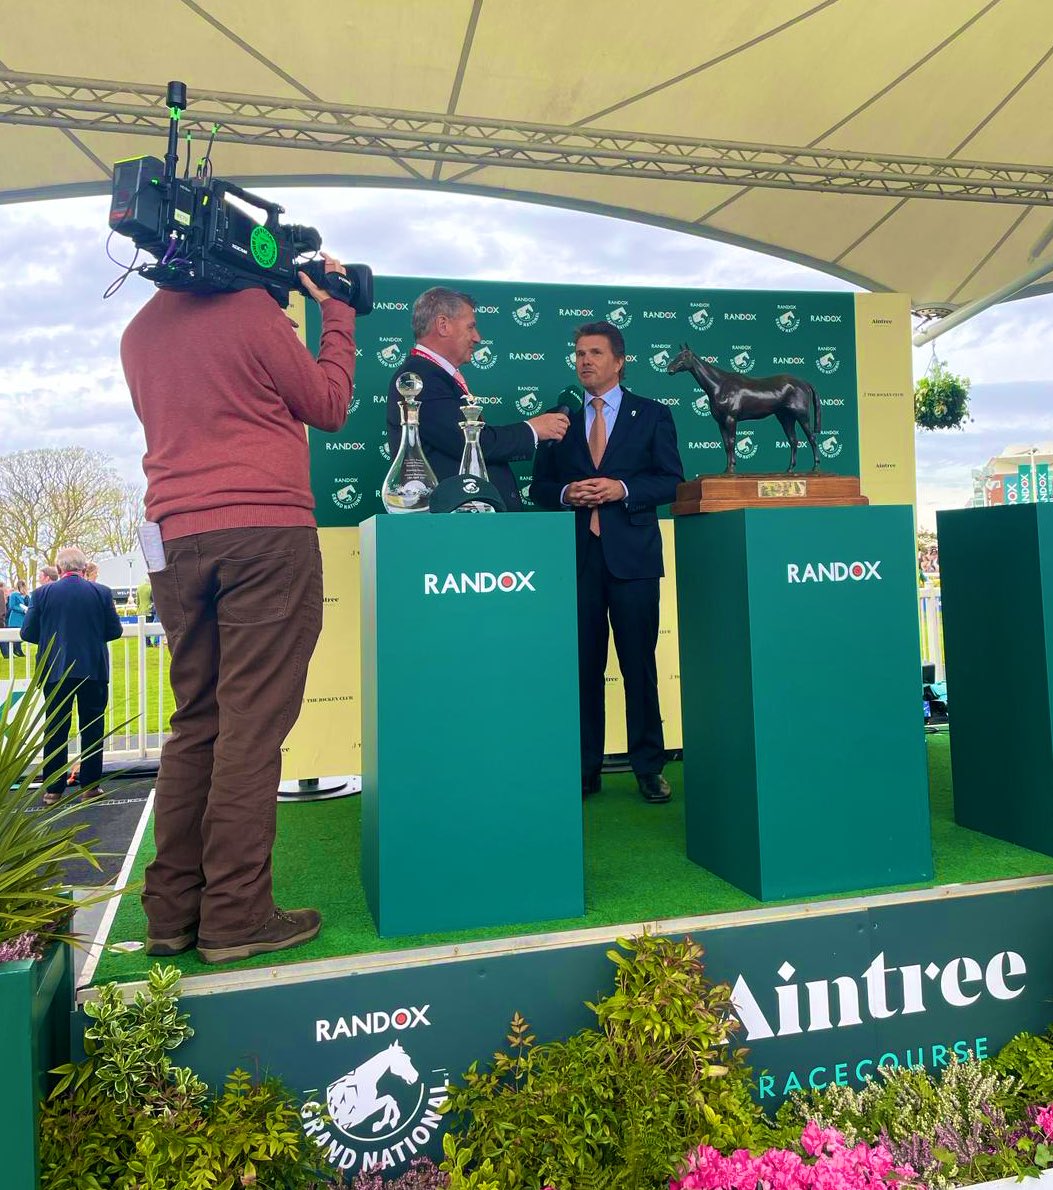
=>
[388,286,568,512]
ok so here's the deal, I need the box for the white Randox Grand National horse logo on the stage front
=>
[300,1004,447,1172]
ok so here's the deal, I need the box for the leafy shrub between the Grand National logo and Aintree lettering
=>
[443,937,765,1190]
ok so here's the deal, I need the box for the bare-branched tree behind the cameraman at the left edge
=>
[0,446,131,584]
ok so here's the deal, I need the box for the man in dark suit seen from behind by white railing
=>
[21,546,123,806]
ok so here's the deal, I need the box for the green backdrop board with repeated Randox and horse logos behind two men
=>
[307,277,859,526]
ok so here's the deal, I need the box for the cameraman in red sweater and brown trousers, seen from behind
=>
[120,257,355,963]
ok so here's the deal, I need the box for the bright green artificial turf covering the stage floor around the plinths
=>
[94,733,1053,983]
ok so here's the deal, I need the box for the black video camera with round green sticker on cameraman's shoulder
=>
[109,82,372,314]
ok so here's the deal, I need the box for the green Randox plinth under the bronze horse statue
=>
[676,507,933,901]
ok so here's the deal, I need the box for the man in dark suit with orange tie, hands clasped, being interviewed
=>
[531,322,684,803]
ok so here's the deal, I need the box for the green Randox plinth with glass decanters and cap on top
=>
[361,513,584,935]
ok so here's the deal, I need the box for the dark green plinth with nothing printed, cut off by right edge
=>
[936,505,1053,854]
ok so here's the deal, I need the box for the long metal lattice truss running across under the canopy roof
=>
[0,71,1053,206]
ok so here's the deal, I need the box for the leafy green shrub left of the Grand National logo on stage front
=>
[40,966,322,1190]
